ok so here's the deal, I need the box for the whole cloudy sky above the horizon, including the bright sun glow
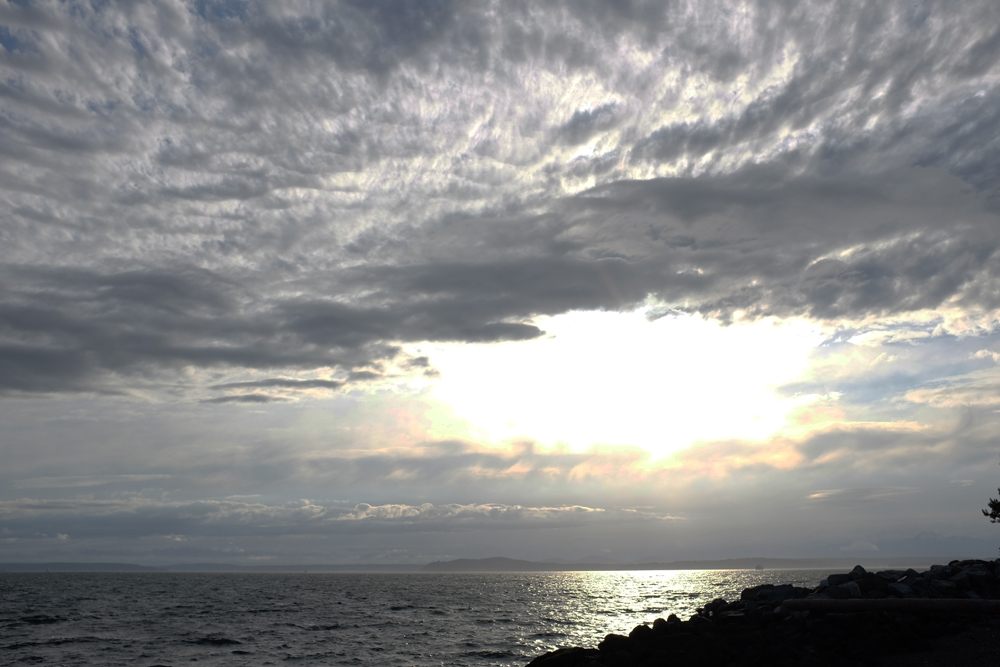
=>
[0,0,1000,565]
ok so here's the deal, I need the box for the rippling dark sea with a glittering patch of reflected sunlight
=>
[0,570,828,667]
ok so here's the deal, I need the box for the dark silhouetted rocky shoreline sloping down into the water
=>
[528,560,1000,667]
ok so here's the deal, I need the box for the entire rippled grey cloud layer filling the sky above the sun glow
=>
[0,2,1000,401]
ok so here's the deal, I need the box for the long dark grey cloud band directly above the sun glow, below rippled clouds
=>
[0,168,1000,392]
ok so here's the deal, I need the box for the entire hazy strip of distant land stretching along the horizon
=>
[0,556,954,573]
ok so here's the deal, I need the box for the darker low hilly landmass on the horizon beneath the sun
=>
[421,557,951,572]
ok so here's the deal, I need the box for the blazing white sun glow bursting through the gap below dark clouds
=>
[423,311,822,457]
